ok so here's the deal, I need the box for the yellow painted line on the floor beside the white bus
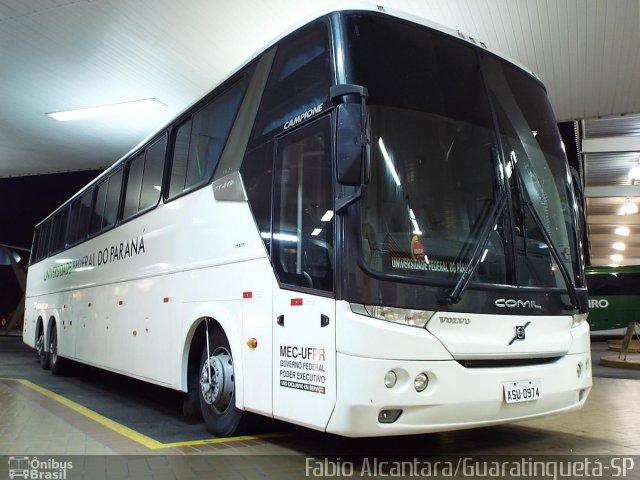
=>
[0,377,272,450]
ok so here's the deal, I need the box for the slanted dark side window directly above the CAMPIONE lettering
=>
[252,23,333,140]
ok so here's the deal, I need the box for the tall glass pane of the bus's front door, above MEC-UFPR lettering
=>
[271,116,334,291]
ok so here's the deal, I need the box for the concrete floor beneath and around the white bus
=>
[0,337,640,479]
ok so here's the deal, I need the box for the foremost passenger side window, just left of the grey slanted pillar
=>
[169,76,248,197]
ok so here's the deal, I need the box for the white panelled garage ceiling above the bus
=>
[0,0,640,263]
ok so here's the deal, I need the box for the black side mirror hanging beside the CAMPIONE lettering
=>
[336,103,366,186]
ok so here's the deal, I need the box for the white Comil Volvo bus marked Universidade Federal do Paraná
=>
[24,4,591,436]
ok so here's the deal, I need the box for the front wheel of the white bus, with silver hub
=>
[198,331,243,437]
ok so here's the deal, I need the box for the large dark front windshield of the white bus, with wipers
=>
[346,15,579,289]
